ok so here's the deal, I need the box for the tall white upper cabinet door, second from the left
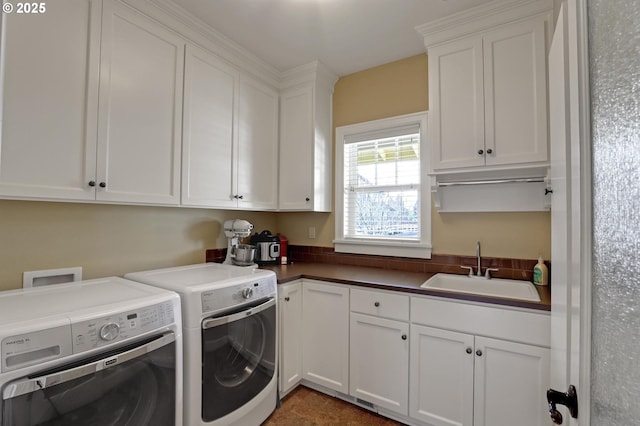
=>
[96,0,184,204]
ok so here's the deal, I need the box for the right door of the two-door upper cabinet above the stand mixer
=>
[237,77,278,210]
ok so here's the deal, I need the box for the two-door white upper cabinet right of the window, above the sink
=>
[425,5,549,173]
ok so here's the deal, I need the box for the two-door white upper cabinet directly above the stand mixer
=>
[182,46,278,210]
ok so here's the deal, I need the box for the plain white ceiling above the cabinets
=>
[172,0,489,76]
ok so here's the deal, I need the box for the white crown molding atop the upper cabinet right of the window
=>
[415,0,553,49]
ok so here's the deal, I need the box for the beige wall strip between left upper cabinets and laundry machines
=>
[0,201,275,290]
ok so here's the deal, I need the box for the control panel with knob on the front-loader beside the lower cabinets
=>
[202,275,277,315]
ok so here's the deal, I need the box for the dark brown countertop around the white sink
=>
[261,262,551,311]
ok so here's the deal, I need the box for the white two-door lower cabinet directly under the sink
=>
[409,298,550,426]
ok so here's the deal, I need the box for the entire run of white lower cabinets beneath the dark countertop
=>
[278,279,550,426]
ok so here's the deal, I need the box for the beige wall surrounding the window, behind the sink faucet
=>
[277,54,551,259]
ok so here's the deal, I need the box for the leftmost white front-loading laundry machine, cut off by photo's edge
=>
[0,277,182,426]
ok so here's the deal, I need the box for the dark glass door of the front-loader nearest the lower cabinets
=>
[202,299,276,422]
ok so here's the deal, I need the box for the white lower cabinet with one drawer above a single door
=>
[349,289,409,416]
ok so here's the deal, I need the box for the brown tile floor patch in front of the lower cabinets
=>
[262,386,402,426]
